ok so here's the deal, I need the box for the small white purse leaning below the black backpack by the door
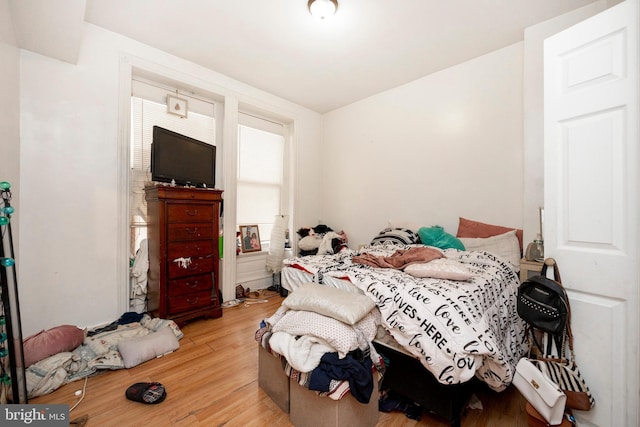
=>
[513,358,567,425]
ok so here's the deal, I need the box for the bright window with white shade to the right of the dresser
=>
[237,113,286,250]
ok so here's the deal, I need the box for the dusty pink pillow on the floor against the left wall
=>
[23,325,84,367]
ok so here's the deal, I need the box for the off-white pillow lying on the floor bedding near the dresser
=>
[118,326,180,368]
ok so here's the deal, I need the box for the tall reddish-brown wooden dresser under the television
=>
[145,185,222,325]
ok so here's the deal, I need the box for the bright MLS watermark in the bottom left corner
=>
[0,404,69,427]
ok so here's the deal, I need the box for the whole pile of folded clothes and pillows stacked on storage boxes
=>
[255,284,384,403]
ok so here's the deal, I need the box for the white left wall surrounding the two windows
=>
[14,24,321,336]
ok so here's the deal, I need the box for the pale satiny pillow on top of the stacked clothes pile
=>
[282,283,375,325]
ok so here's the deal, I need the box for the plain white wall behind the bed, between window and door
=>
[322,43,523,247]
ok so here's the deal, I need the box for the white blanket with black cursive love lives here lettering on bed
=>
[346,250,528,391]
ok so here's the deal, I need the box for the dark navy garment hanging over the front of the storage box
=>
[309,353,373,403]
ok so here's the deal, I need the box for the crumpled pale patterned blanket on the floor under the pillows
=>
[26,314,184,398]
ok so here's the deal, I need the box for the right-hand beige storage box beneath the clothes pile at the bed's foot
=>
[289,373,378,427]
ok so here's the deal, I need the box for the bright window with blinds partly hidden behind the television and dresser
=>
[129,80,216,256]
